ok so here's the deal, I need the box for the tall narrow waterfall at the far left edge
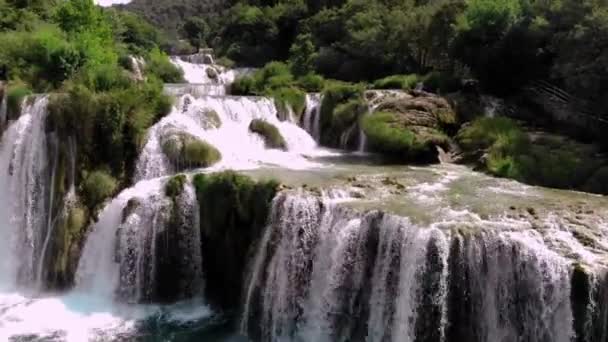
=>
[0,96,50,288]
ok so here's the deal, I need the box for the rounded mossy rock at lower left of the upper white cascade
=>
[161,132,222,171]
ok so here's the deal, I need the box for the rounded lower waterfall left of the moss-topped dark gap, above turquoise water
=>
[76,179,202,303]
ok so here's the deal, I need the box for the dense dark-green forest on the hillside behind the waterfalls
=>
[122,0,608,114]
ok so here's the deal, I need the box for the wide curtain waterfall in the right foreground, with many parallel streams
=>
[241,193,606,342]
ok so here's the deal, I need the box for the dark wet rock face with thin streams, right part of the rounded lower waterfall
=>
[115,183,203,303]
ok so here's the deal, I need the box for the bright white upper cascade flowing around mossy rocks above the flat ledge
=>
[136,95,319,179]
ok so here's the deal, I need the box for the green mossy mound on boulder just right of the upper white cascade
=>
[362,112,448,161]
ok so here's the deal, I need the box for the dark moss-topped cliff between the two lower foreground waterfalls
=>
[193,171,278,309]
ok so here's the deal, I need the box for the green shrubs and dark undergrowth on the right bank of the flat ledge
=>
[456,117,602,190]
